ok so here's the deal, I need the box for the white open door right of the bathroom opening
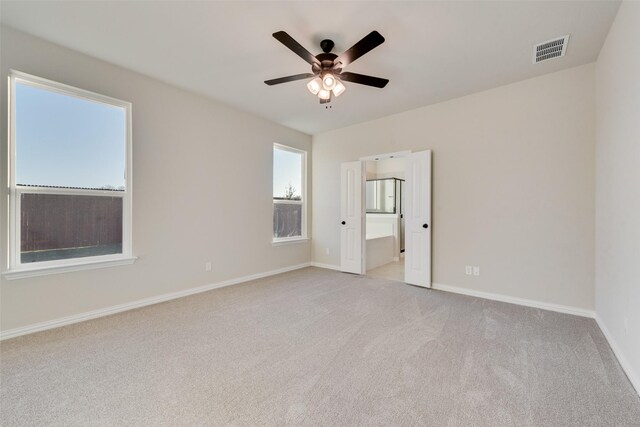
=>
[404,150,431,288]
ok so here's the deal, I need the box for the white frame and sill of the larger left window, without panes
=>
[3,70,136,279]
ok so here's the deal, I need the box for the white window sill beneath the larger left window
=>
[2,254,138,280]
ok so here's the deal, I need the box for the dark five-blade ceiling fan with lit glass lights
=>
[265,31,389,104]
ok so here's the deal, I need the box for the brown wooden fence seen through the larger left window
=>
[20,193,122,252]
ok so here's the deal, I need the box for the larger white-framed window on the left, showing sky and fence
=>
[8,71,131,277]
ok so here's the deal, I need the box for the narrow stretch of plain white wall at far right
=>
[596,2,640,392]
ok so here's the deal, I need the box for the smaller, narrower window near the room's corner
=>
[273,144,307,242]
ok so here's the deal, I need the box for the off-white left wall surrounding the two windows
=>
[0,28,311,331]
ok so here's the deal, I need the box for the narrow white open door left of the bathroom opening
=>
[340,161,365,274]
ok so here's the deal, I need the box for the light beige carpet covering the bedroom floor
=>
[0,268,640,426]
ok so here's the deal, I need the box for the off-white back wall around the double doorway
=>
[313,64,595,310]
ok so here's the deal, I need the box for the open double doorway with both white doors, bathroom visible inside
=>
[340,150,431,288]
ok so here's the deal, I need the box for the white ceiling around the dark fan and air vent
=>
[0,1,619,134]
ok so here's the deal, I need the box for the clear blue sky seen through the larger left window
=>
[16,83,126,188]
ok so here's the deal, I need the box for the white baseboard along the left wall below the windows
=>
[0,262,311,341]
